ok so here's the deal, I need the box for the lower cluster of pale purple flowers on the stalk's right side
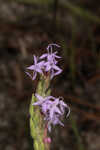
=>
[33,94,70,131]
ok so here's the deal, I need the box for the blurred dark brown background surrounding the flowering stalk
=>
[0,0,100,150]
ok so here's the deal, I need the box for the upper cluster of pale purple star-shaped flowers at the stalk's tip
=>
[26,44,62,80]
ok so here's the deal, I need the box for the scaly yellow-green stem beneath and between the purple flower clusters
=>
[29,77,50,150]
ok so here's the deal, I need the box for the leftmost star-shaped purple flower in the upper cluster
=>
[26,55,44,80]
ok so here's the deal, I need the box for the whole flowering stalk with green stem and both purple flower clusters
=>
[26,44,70,150]
